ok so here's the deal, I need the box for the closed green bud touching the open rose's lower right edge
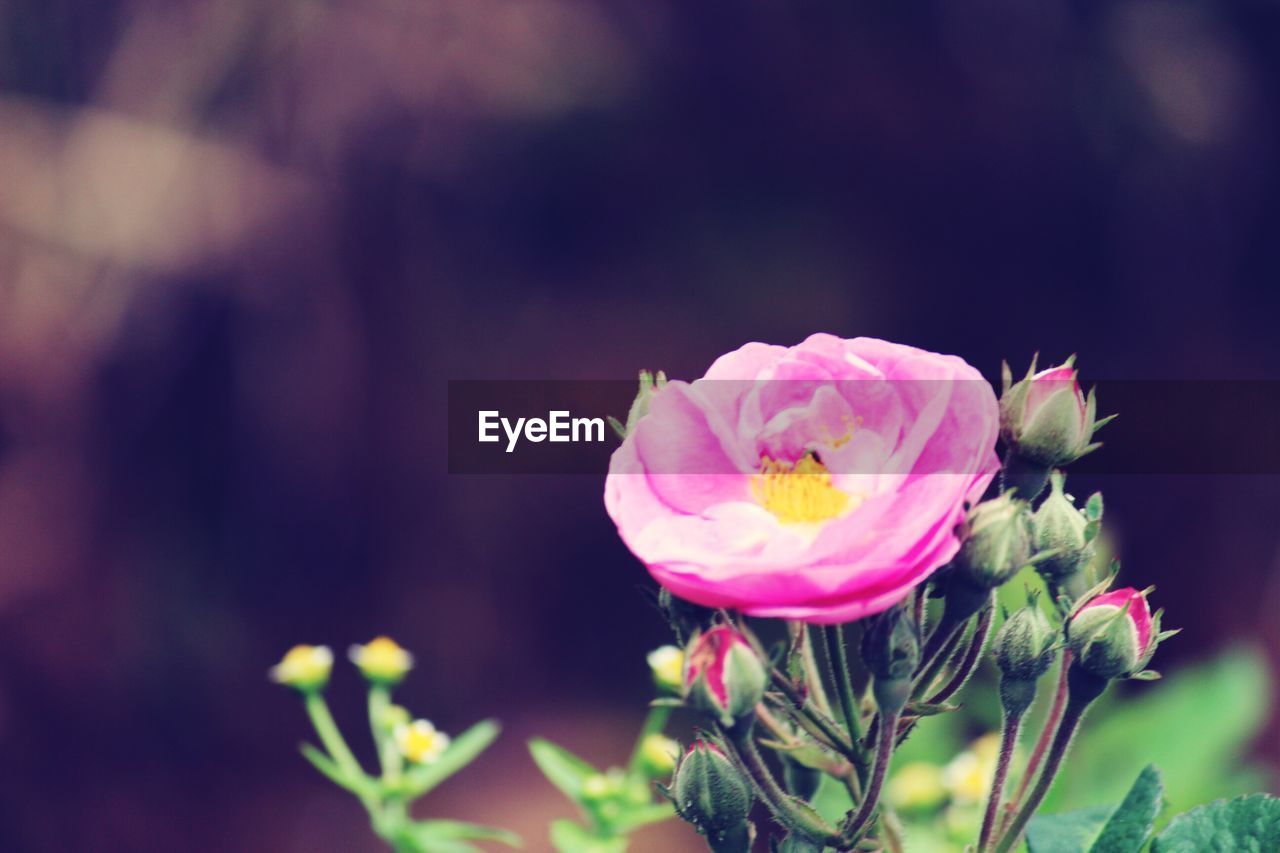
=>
[955,492,1032,589]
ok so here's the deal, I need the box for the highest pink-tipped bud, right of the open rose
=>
[1000,356,1111,468]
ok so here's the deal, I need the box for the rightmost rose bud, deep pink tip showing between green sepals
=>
[1066,587,1176,679]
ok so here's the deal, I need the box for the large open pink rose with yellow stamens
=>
[604,334,998,624]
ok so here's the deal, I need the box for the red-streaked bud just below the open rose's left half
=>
[685,625,767,726]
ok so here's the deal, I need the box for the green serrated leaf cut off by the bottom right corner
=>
[1151,794,1280,853]
